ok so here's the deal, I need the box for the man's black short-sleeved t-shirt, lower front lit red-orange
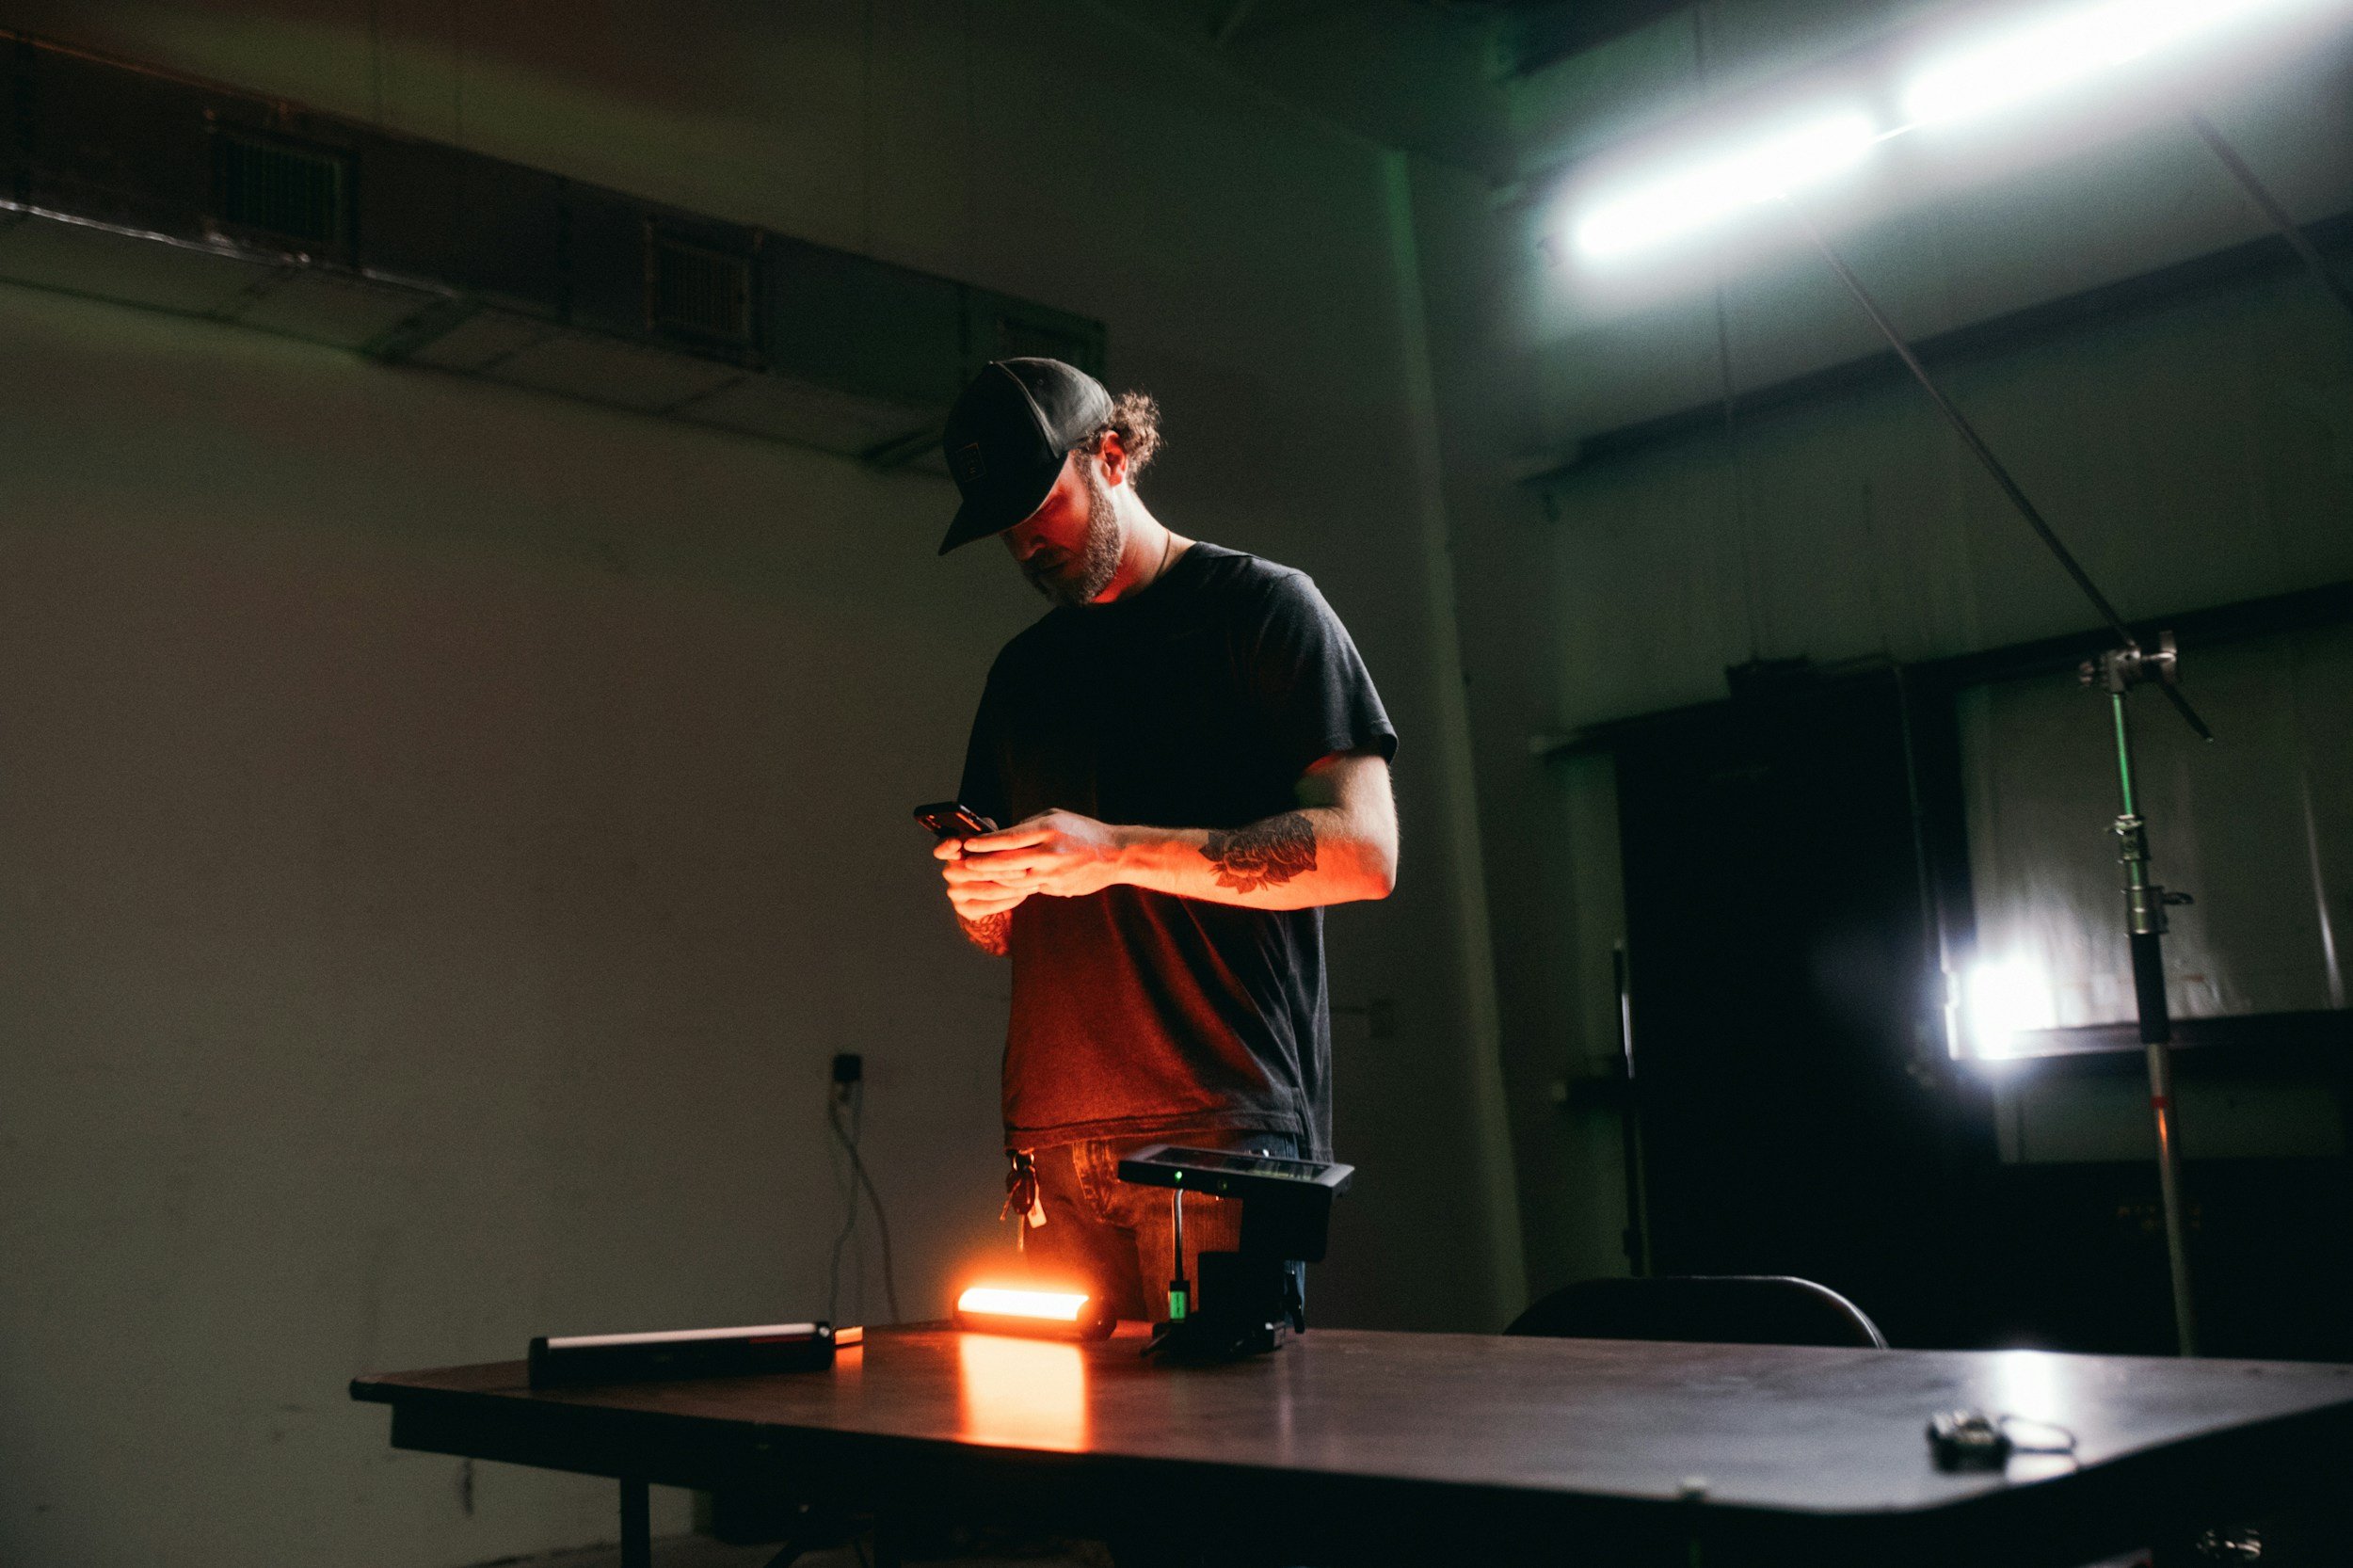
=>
[960,544,1398,1159]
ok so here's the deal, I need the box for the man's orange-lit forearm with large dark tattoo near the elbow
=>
[1120,806,1396,909]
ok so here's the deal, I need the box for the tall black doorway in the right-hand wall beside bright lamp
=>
[1617,671,1991,1347]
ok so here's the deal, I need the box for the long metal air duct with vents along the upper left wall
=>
[0,31,1104,464]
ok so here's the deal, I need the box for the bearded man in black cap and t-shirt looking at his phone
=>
[936,358,1398,1319]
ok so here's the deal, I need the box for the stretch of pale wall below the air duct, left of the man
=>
[0,292,1007,1563]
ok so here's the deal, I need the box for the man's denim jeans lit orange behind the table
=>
[1024,1128,1304,1323]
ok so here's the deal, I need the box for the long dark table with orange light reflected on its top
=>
[351,1328,2353,1568]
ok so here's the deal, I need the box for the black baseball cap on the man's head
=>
[939,360,1111,555]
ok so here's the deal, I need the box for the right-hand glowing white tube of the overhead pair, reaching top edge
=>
[1904,0,2315,130]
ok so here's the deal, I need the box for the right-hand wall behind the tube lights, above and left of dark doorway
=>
[1424,0,2353,1290]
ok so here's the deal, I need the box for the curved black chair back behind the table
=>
[1504,1273,1887,1349]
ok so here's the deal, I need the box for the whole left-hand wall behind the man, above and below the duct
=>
[0,0,1520,1563]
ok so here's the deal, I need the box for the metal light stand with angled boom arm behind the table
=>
[1782,196,2215,1356]
